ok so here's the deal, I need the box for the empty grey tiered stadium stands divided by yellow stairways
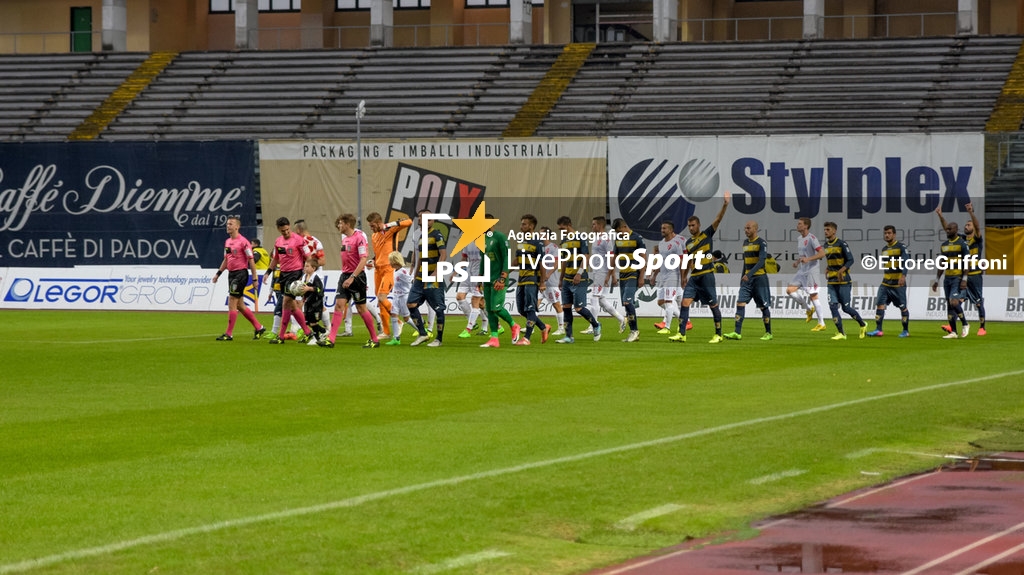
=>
[0,36,1021,141]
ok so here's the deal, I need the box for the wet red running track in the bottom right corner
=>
[595,453,1024,575]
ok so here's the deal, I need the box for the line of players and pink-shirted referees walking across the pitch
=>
[213,191,986,348]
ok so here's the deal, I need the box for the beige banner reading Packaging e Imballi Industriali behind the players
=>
[260,138,607,269]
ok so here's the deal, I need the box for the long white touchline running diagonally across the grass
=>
[0,369,1024,575]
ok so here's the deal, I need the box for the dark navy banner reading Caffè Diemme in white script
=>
[0,141,256,268]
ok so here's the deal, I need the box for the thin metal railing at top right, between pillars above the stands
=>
[677,12,957,42]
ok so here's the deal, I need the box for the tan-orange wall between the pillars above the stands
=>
[0,0,1024,53]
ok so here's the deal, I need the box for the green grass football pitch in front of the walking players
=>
[0,310,1024,574]
